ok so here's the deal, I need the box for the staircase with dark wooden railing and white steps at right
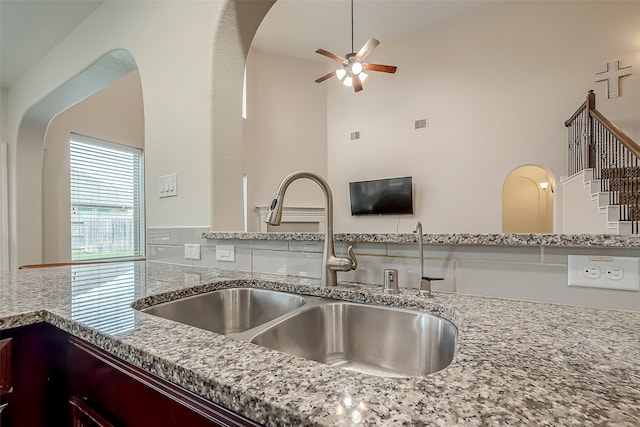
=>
[561,91,640,234]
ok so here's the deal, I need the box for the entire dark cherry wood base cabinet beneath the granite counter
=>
[0,323,259,427]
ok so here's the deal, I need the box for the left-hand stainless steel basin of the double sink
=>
[142,288,305,335]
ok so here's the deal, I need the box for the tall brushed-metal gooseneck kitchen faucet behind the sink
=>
[265,171,358,286]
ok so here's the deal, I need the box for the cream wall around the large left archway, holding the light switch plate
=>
[8,0,228,268]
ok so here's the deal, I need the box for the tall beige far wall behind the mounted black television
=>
[328,1,640,233]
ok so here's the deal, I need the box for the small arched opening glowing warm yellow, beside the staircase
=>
[502,165,554,233]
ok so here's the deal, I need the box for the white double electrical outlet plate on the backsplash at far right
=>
[568,255,640,291]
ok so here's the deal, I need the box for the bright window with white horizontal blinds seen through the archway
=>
[69,134,144,260]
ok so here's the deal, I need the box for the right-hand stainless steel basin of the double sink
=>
[251,302,458,377]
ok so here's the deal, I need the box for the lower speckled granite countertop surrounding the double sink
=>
[0,262,640,426]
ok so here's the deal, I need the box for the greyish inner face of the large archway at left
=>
[10,49,137,270]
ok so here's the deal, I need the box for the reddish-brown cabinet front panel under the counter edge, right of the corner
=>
[68,337,259,427]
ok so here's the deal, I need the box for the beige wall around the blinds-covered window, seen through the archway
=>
[42,71,144,263]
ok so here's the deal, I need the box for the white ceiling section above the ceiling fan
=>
[252,0,504,62]
